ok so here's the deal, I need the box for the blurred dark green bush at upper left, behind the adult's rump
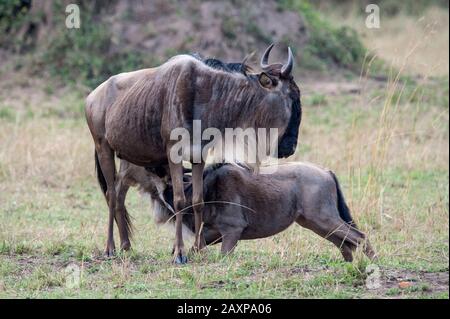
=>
[0,0,148,87]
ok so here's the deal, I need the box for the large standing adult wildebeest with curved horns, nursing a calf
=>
[86,45,301,263]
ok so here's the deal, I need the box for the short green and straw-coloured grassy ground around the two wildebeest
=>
[0,5,449,298]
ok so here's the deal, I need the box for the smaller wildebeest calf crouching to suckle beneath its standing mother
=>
[118,163,375,261]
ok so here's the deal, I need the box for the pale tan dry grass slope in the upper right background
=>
[326,6,449,76]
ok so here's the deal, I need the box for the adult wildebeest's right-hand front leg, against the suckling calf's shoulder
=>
[192,163,205,251]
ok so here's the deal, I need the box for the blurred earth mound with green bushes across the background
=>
[0,0,448,88]
